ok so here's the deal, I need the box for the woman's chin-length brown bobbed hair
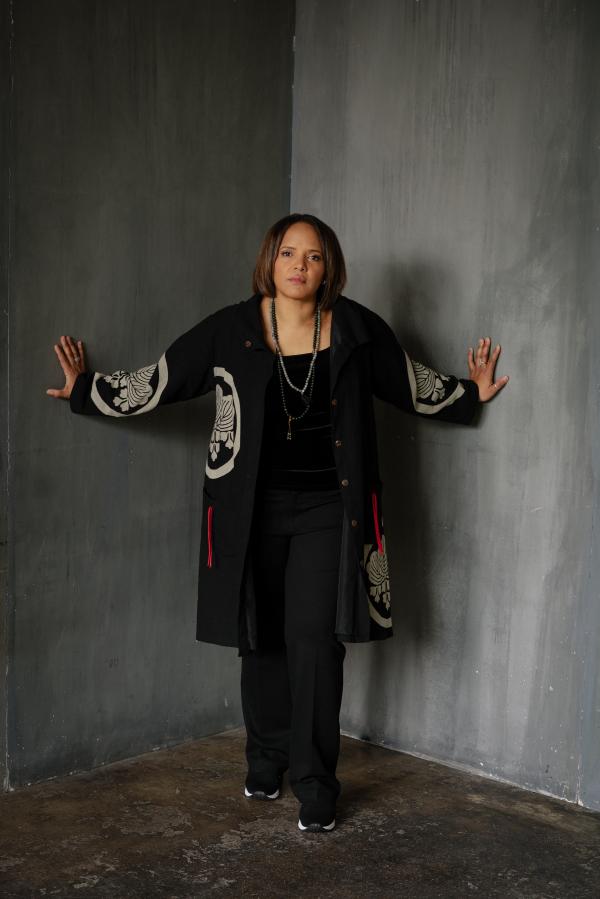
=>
[252,212,346,309]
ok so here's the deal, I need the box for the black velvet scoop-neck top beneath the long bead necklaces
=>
[258,347,339,490]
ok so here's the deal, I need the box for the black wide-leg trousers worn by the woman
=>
[241,488,346,802]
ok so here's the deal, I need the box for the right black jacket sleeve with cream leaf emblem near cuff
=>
[371,310,479,424]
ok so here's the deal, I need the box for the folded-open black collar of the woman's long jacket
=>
[239,293,371,395]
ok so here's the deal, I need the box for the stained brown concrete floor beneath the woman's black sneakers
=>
[0,730,600,899]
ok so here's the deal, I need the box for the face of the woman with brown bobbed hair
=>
[273,222,325,300]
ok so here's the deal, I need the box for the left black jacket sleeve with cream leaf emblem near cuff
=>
[69,312,217,418]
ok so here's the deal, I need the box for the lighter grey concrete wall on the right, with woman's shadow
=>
[291,0,600,808]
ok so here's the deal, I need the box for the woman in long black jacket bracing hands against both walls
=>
[48,214,508,832]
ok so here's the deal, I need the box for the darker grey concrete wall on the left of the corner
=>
[0,0,293,785]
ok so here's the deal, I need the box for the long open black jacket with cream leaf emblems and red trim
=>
[70,294,479,654]
